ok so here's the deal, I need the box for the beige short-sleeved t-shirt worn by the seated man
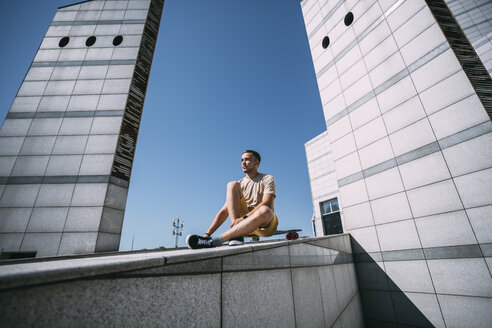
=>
[239,173,277,209]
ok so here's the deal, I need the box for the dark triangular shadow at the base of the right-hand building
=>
[350,236,434,328]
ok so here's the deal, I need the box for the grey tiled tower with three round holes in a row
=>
[0,0,164,256]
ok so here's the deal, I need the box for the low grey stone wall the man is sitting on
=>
[0,235,364,328]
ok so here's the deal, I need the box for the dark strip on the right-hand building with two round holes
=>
[425,0,492,119]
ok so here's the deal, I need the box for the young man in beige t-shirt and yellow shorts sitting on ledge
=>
[186,150,278,249]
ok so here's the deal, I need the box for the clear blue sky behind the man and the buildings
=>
[0,0,325,250]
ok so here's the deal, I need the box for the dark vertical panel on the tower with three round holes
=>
[111,0,164,181]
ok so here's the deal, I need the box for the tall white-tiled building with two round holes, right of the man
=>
[301,0,492,327]
